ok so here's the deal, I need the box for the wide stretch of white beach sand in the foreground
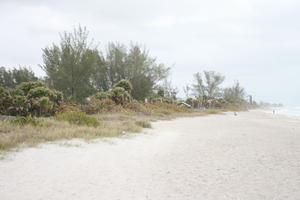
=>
[0,111,300,200]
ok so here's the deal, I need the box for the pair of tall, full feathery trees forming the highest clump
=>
[41,26,169,102]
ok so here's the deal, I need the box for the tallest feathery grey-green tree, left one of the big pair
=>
[41,26,99,101]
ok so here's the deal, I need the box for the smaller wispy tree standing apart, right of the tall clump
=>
[193,71,225,98]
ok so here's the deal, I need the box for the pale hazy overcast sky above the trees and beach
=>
[0,0,300,105]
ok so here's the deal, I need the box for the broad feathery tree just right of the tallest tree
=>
[106,43,169,100]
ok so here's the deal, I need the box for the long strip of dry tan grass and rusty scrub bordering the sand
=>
[0,103,226,152]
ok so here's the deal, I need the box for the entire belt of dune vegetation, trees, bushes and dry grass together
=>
[0,27,256,151]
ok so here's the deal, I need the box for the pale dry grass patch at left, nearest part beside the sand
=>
[0,116,147,151]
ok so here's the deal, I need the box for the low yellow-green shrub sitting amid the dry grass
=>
[55,111,100,127]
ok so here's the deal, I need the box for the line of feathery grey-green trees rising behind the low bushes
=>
[0,26,250,107]
